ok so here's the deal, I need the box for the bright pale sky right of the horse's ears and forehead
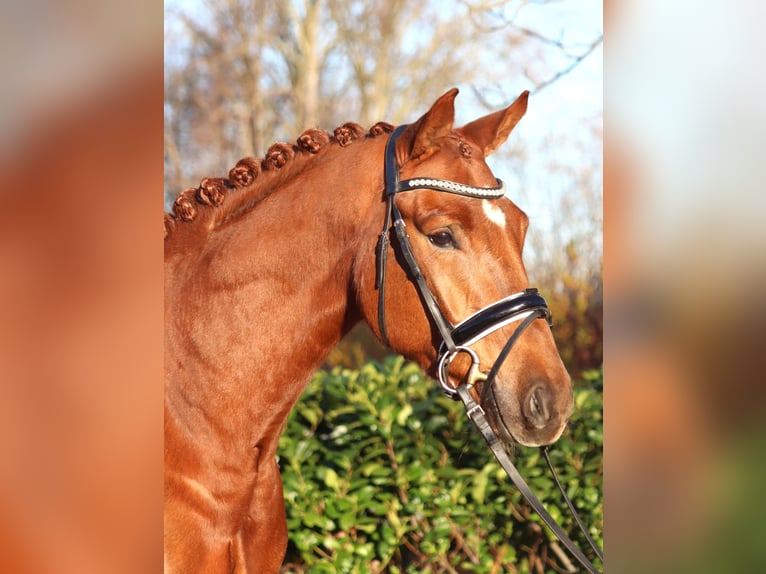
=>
[438,0,604,273]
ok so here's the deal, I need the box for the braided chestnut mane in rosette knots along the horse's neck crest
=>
[164,122,394,240]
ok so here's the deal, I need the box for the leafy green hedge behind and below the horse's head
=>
[279,357,603,574]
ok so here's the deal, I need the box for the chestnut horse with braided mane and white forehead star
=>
[164,89,572,574]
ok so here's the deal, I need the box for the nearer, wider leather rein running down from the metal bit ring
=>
[457,384,600,574]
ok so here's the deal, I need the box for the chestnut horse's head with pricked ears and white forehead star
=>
[356,89,572,446]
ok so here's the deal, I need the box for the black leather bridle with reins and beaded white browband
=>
[375,125,604,574]
